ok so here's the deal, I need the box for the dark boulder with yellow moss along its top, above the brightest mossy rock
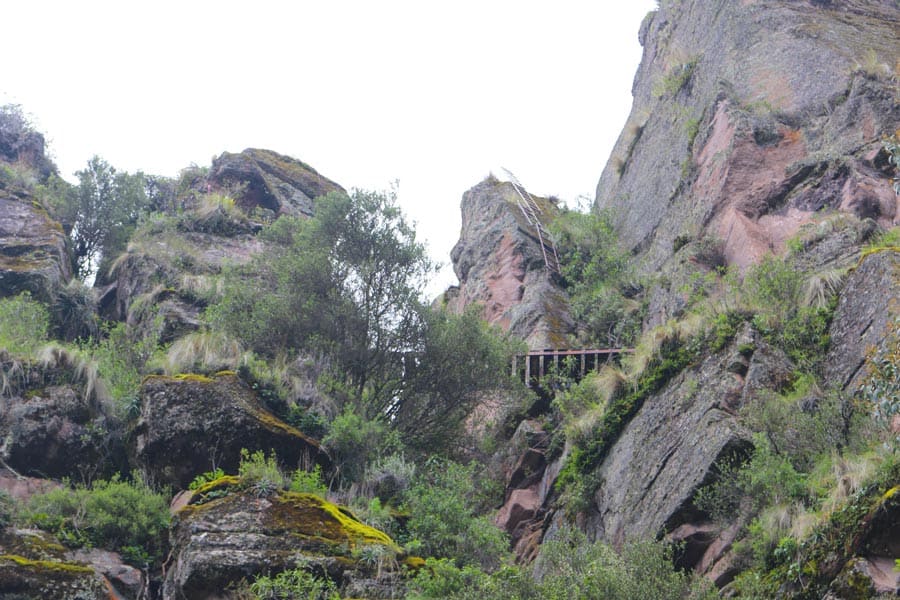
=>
[134,372,329,489]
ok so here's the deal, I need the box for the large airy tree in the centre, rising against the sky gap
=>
[208,191,433,419]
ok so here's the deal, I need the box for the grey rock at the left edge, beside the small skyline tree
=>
[0,188,72,302]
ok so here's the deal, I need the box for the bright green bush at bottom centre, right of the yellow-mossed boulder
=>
[404,459,509,570]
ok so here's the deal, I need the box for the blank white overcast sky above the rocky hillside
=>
[0,0,656,292]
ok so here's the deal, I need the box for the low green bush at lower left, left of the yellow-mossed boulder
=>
[25,473,169,566]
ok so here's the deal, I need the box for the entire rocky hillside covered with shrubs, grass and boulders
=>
[0,0,900,600]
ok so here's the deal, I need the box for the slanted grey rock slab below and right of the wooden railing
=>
[555,326,793,566]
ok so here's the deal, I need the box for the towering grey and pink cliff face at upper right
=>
[596,0,900,273]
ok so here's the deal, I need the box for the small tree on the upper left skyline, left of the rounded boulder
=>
[59,156,147,280]
